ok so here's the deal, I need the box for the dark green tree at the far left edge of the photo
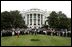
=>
[1,11,10,29]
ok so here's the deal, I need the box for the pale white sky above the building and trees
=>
[1,1,71,18]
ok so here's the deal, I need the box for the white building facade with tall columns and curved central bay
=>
[22,8,48,28]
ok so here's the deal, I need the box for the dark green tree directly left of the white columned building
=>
[10,10,24,28]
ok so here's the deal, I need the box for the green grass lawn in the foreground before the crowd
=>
[1,35,71,46]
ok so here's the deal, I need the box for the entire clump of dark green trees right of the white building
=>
[48,11,71,29]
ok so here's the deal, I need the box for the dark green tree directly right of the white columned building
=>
[48,11,58,28]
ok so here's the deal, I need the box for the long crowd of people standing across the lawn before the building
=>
[1,28,71,37]
